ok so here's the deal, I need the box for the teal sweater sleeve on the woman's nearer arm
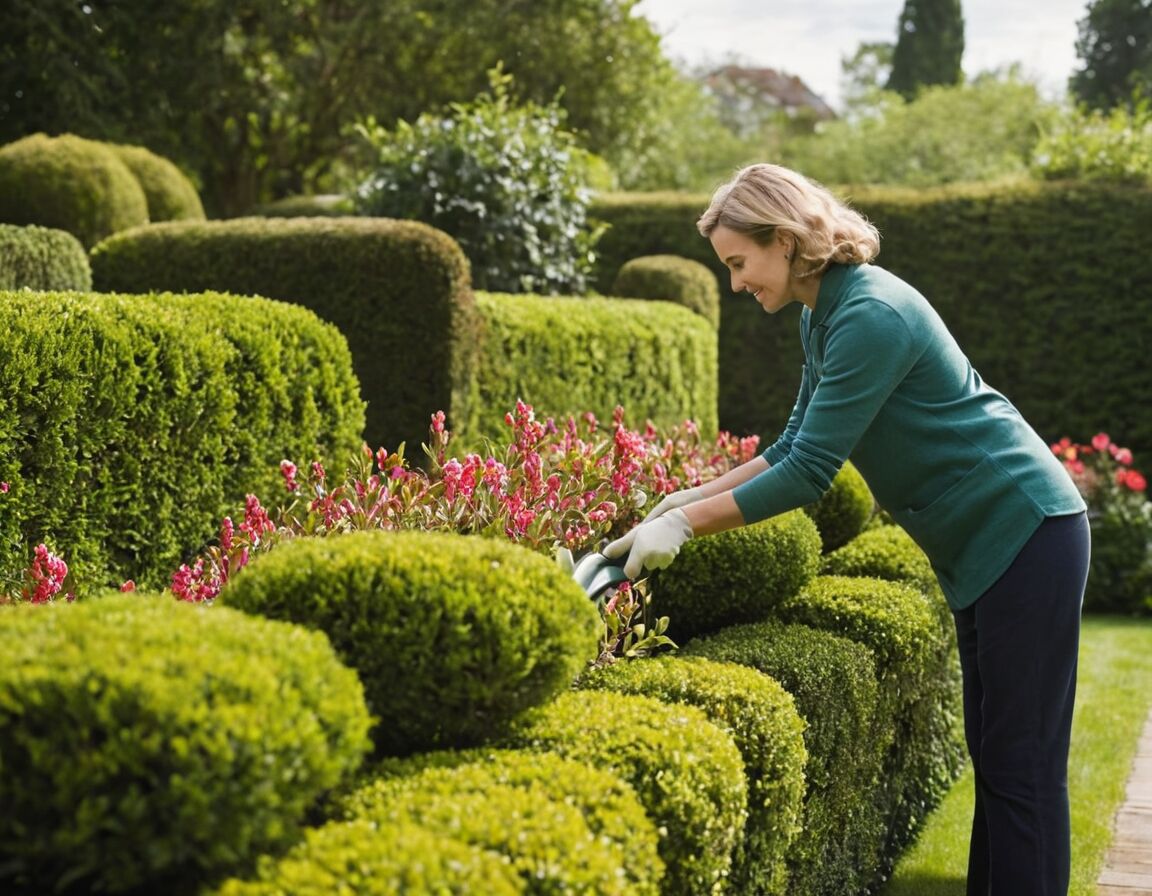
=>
[733,298,917,523]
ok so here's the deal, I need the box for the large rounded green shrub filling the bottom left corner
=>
[0,593,370,894]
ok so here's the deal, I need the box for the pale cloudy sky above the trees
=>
[634,0,1089,108]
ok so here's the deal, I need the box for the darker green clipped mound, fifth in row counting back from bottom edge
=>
[681,620,893,896]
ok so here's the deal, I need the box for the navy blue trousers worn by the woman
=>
[953,514,1091,896]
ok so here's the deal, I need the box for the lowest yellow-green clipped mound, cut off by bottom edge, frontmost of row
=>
[214,820,524,896]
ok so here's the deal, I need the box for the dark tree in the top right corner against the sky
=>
[1068,0,1152,111]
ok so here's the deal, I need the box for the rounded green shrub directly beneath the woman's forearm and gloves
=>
[650,510,820,643]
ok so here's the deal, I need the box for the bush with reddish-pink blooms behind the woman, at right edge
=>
[1052,432,1152,613]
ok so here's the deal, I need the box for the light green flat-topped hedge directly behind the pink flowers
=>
[464,293,717,439]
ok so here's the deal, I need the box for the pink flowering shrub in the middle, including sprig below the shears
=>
[172,402,758,659]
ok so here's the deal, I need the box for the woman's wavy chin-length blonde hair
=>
[696,162,880,276]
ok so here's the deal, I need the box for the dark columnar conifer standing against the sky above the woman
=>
[887,0,964,99]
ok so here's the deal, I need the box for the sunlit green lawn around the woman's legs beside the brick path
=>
[880,616,1152,896]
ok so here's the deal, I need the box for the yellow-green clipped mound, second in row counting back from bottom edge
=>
[340,750,664,896]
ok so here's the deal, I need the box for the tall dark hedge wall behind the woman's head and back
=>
[593,183,1152,454]
